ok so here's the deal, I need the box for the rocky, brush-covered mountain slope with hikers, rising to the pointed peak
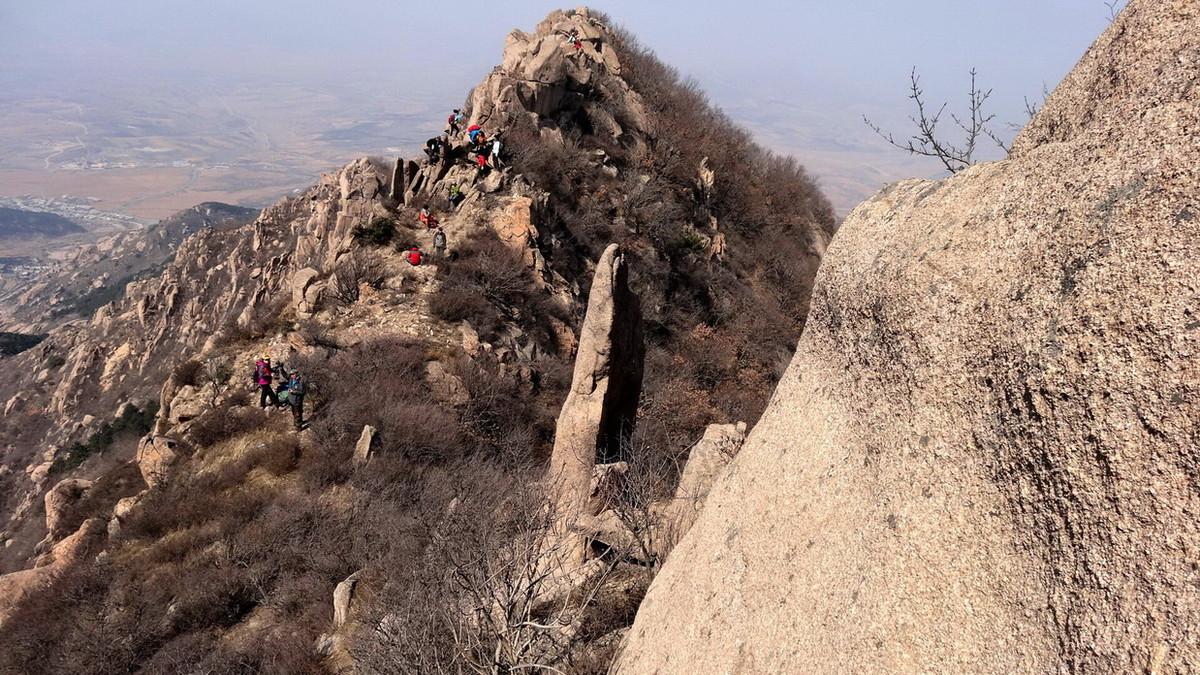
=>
[0,6,833,673]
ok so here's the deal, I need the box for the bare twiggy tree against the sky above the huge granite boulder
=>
[863,66,1008,173]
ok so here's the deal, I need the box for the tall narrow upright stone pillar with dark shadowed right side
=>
[547,244,646,562]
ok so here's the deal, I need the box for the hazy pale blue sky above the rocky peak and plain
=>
[0,0,1123,210]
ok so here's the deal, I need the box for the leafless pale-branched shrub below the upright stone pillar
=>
[359,485,612,675]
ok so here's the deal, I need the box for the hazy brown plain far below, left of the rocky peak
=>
[0,74,446,220]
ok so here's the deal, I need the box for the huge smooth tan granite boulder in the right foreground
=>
[618,0,1200,673]
